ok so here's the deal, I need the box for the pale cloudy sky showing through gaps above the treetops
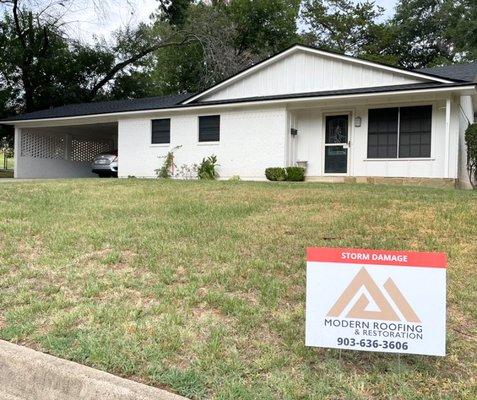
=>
[0,0,397,43]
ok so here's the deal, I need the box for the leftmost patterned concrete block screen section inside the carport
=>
[20,132,66,159]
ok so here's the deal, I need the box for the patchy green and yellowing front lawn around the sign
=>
[0,179,477,399]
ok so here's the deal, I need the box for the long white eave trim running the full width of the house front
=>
[6,84,477,126]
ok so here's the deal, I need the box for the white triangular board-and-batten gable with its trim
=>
[184,45,452,104]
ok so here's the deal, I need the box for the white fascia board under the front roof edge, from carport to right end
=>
[2,84,477,128]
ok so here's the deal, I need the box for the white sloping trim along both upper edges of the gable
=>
[181,45,454,104]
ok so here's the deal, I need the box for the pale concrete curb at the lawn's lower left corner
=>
[0,340,187,400]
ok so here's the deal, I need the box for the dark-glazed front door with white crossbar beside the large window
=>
[325,115,349,174]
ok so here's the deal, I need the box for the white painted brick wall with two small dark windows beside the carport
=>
[118,107,287,180]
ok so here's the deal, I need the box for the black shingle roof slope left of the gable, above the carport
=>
[3,93,191,121]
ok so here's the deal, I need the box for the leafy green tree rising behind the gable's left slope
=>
[148,0,300,93]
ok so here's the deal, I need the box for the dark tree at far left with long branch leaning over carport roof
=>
[0,0,193,112]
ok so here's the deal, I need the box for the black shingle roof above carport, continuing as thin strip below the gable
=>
[0,82,470,123]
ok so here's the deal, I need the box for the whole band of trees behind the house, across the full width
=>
[0,0,477,131]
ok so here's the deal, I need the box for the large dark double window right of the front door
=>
[368,106,432,158]
